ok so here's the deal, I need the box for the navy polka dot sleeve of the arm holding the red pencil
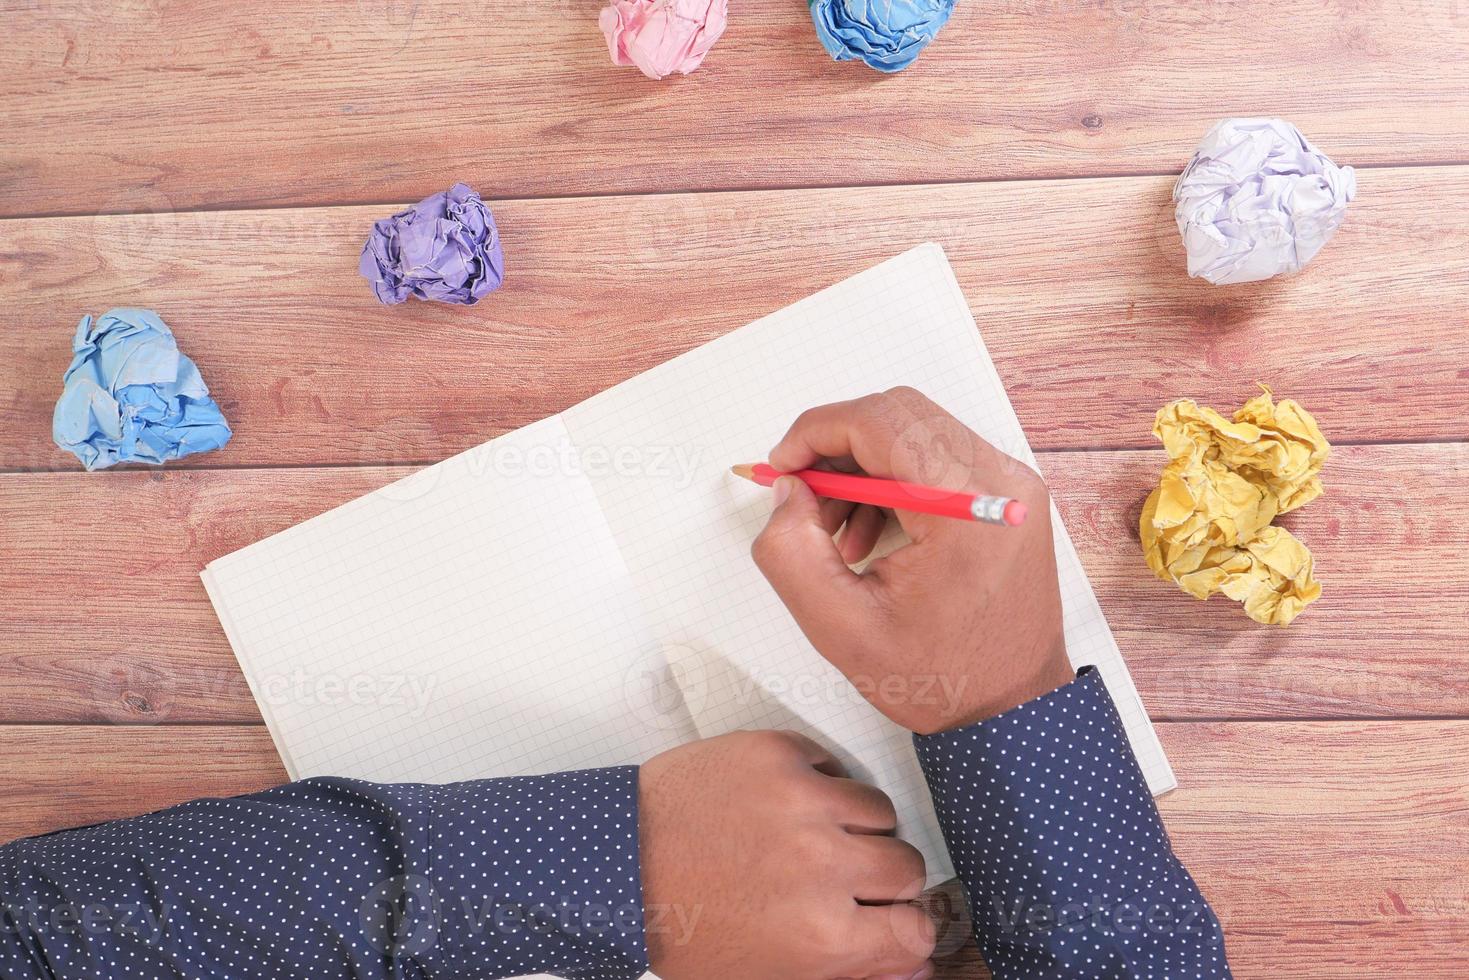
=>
[915,667,1230,980]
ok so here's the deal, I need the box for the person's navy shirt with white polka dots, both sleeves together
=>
[0,669,1230,980]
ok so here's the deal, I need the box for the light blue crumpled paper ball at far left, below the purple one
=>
[51,309,232,470]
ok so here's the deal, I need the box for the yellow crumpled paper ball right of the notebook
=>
[1138,385,1331,626]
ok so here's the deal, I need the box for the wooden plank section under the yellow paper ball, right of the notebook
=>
[1042,444,1469,718]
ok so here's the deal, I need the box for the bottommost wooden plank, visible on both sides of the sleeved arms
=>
[0,721,1469,980]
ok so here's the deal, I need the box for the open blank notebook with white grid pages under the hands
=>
[203,245,1174,910]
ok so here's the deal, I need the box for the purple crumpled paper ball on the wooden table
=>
[357,184,505,306]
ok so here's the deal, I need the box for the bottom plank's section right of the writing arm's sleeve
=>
[1162,721,1469,979]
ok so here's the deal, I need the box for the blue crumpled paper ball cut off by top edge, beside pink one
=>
[811,0,956,72]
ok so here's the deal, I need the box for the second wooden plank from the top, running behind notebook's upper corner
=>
[0,167,1469,469]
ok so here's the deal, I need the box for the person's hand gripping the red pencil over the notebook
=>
[754,388,1072,733]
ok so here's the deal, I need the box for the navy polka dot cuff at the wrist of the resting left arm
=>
[407,765,648,980]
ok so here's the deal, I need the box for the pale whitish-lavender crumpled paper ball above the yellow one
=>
[1174,119,1357,285]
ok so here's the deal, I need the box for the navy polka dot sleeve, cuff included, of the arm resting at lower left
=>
[0,767,648,980]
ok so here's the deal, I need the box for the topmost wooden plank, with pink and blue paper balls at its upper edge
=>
[0,0,1469,215]
